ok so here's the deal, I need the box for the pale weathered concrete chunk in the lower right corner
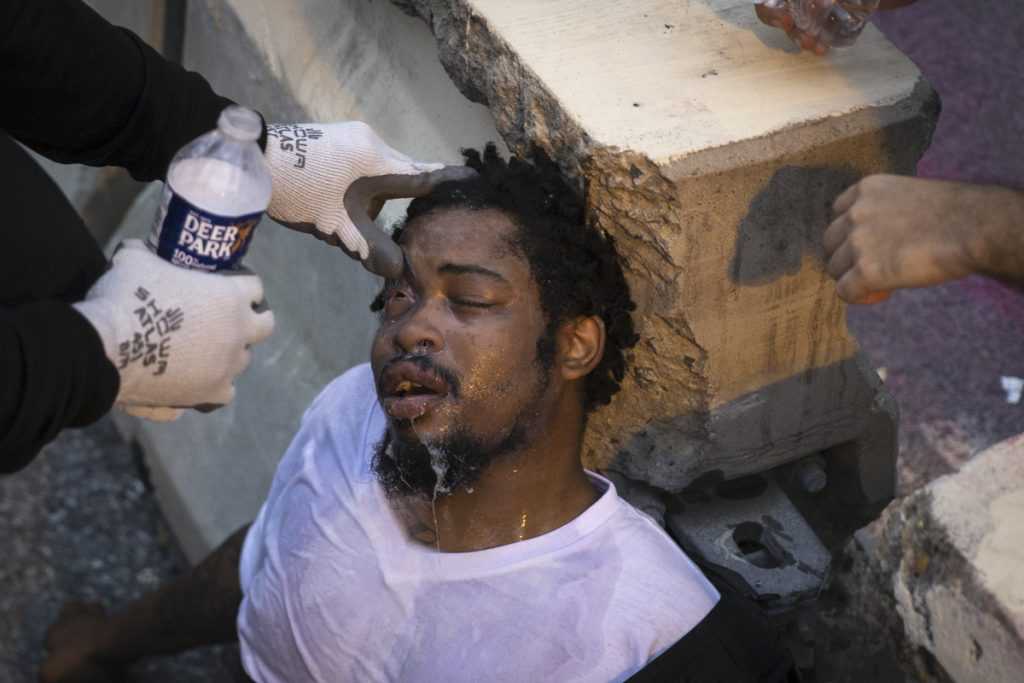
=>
[885,436,1024,683]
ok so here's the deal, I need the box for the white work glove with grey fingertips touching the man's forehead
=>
[265,121,467,276]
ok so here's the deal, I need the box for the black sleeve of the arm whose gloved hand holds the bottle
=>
[0,301,119,473]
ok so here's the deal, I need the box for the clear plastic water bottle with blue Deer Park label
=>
[146,105,271,271]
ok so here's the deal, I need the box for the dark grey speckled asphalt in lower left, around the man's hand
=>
[0,420,233,683]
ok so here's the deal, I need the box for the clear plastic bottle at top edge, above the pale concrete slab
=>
[755,0,879,47]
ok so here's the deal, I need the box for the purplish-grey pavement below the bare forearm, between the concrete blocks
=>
[849,278,1024,495]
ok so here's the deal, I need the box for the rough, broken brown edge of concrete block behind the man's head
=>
[392,0,710,475]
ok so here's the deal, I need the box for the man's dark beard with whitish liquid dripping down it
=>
[373,418,526,499]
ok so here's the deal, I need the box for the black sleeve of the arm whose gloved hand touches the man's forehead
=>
[0,0,231,180]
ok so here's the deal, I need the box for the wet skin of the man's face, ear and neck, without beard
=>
[371,209,604,552]
